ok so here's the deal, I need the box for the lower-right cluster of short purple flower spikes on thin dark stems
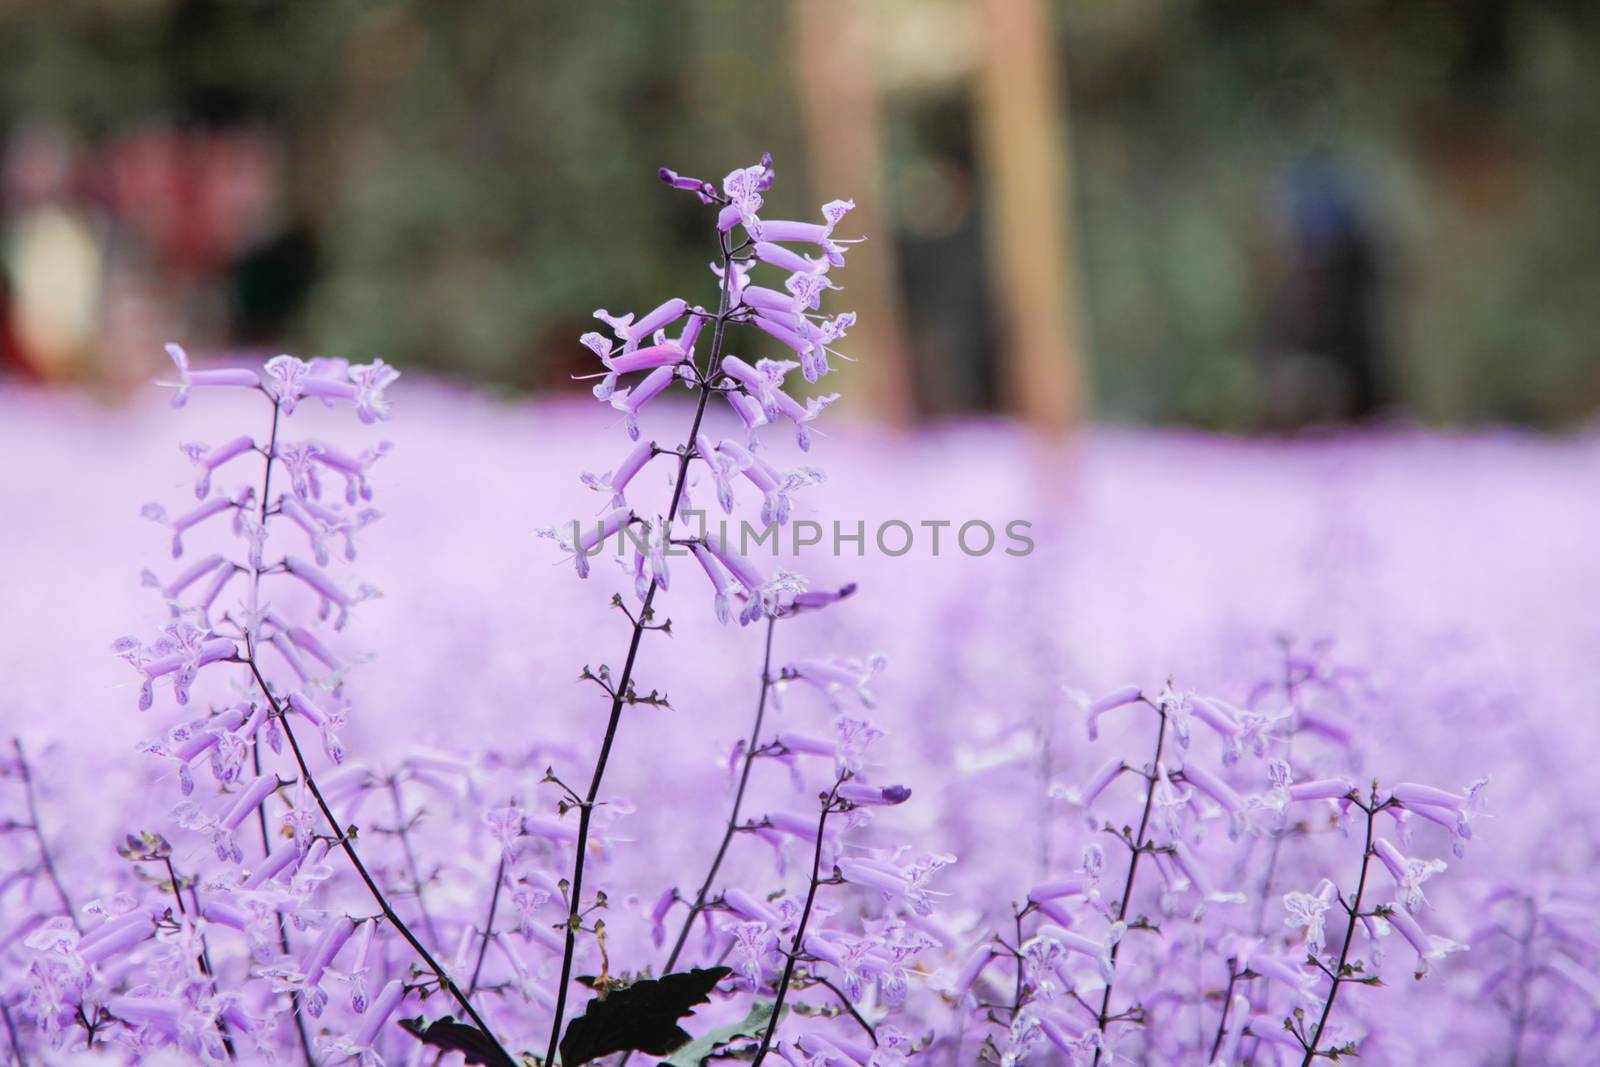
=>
[950,668,1486,1067]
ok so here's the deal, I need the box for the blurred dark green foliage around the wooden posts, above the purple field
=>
[0,0,1600,427]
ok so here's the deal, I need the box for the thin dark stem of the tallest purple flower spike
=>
[544,234,733,1067]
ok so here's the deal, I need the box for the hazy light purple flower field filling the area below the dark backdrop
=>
[0,348,1600,1067]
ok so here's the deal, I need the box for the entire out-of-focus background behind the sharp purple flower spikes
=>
[0,0,1600,1067]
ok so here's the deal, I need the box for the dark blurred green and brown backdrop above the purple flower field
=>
[0,0,1600,430]
